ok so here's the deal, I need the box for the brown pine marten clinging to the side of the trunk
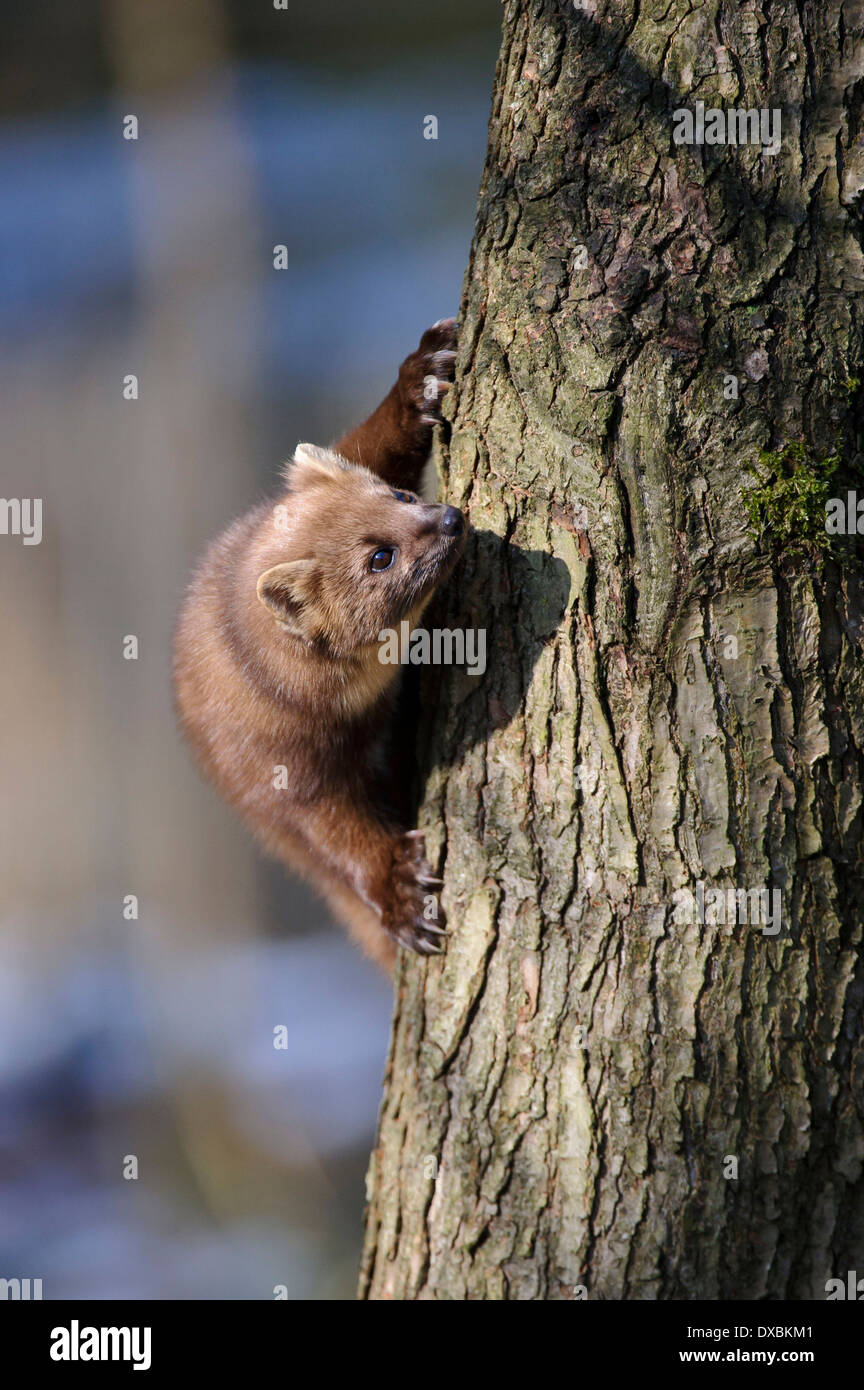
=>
[175,318,467,969]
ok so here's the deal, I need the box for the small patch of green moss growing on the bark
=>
[743,439,840,552]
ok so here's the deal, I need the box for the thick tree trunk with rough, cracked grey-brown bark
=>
[361,0,864,1300]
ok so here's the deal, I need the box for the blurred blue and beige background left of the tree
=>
[0,0,500,1300]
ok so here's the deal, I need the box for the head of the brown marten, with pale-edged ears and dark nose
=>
[257,443,465,656]
